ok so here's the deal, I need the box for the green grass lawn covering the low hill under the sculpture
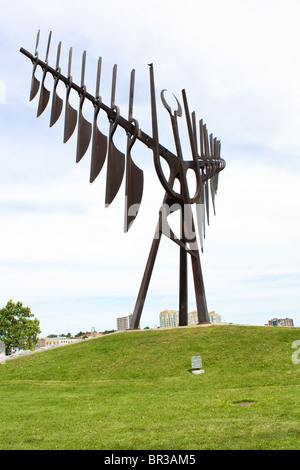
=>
[0,325,300,450]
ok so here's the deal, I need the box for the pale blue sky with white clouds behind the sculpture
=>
[0,0,300,335]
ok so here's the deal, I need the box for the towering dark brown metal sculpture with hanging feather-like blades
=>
[20,32,225,329]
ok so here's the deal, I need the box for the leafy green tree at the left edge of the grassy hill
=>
[0,299,41,354]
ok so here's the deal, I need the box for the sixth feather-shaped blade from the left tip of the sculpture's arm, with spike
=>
[90,57,107,183]
